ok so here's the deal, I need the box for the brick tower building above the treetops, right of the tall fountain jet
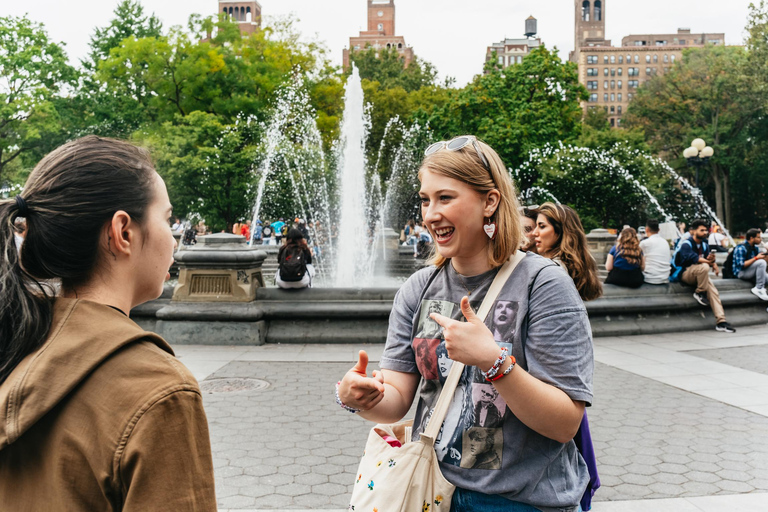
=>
[344,0,413,68]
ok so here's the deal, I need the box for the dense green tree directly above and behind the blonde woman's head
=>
[429,46,587,167]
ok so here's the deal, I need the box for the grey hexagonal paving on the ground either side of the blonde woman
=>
[204,356,768,510]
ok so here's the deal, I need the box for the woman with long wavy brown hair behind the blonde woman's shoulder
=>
[534,203,603,301]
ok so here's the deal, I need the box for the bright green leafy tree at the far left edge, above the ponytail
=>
[0,16,77,179]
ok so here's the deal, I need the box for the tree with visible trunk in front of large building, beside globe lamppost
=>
[625,46,760,228]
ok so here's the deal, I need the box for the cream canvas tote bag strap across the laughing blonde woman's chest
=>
[421,251,525,445]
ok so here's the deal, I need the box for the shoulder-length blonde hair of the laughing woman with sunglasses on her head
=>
[419,140,523,267]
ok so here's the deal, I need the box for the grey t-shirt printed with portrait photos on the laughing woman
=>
[380,254,594,511]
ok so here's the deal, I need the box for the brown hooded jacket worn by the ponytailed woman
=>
[0,299,216,512]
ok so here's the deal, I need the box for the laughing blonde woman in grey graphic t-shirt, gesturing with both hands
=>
[336,136,594,512]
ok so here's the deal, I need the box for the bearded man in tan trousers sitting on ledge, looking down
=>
[675,219,736,332]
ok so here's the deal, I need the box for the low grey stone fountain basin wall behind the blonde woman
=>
[131,279,768,345]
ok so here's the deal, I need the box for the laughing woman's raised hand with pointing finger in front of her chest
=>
[429,296,501,371]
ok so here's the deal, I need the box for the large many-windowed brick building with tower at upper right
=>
[570,0,725,126]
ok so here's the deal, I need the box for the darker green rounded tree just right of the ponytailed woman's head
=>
[135,111,258,231]
